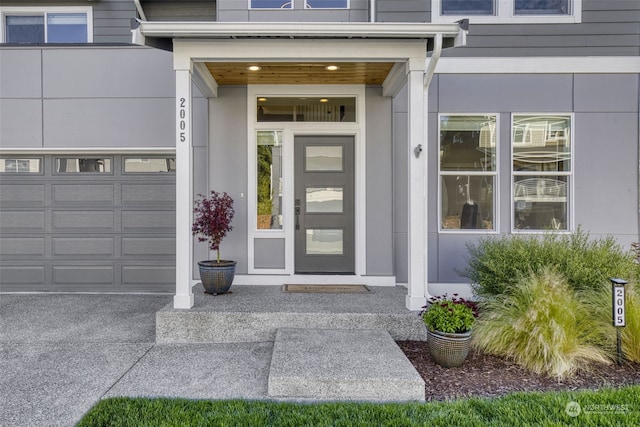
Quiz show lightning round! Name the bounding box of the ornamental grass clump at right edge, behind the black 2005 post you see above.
[579,282,640,363]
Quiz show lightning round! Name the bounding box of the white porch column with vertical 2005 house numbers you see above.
[173,52,193,308]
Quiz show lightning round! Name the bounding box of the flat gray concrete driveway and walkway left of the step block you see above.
[0,294,424,427]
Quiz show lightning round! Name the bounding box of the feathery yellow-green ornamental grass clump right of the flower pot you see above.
[473,267,610,378]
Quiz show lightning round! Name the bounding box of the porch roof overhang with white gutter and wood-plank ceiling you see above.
[137,21,468,97]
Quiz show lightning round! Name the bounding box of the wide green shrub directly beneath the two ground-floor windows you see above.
[458,229,640,298]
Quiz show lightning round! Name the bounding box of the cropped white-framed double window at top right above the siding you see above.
[431,0,582,24]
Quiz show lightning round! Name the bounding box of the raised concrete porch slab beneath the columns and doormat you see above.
[156,285,427,343]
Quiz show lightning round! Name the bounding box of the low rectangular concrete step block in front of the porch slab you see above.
[268,328,425,401]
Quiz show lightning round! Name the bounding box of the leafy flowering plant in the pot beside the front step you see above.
[420,294,477,334]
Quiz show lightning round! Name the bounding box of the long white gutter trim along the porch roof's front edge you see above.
[140,21,465,40]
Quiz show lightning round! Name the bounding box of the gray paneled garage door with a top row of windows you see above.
[0,154,175,292]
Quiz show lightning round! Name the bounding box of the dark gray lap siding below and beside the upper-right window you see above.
[443,0,640,57]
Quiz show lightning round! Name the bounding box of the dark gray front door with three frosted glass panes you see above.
[294,136,355,274]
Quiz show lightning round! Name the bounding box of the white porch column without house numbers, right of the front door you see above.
[406,59,427,310]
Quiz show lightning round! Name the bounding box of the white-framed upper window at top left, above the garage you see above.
[0,6,93,44]
